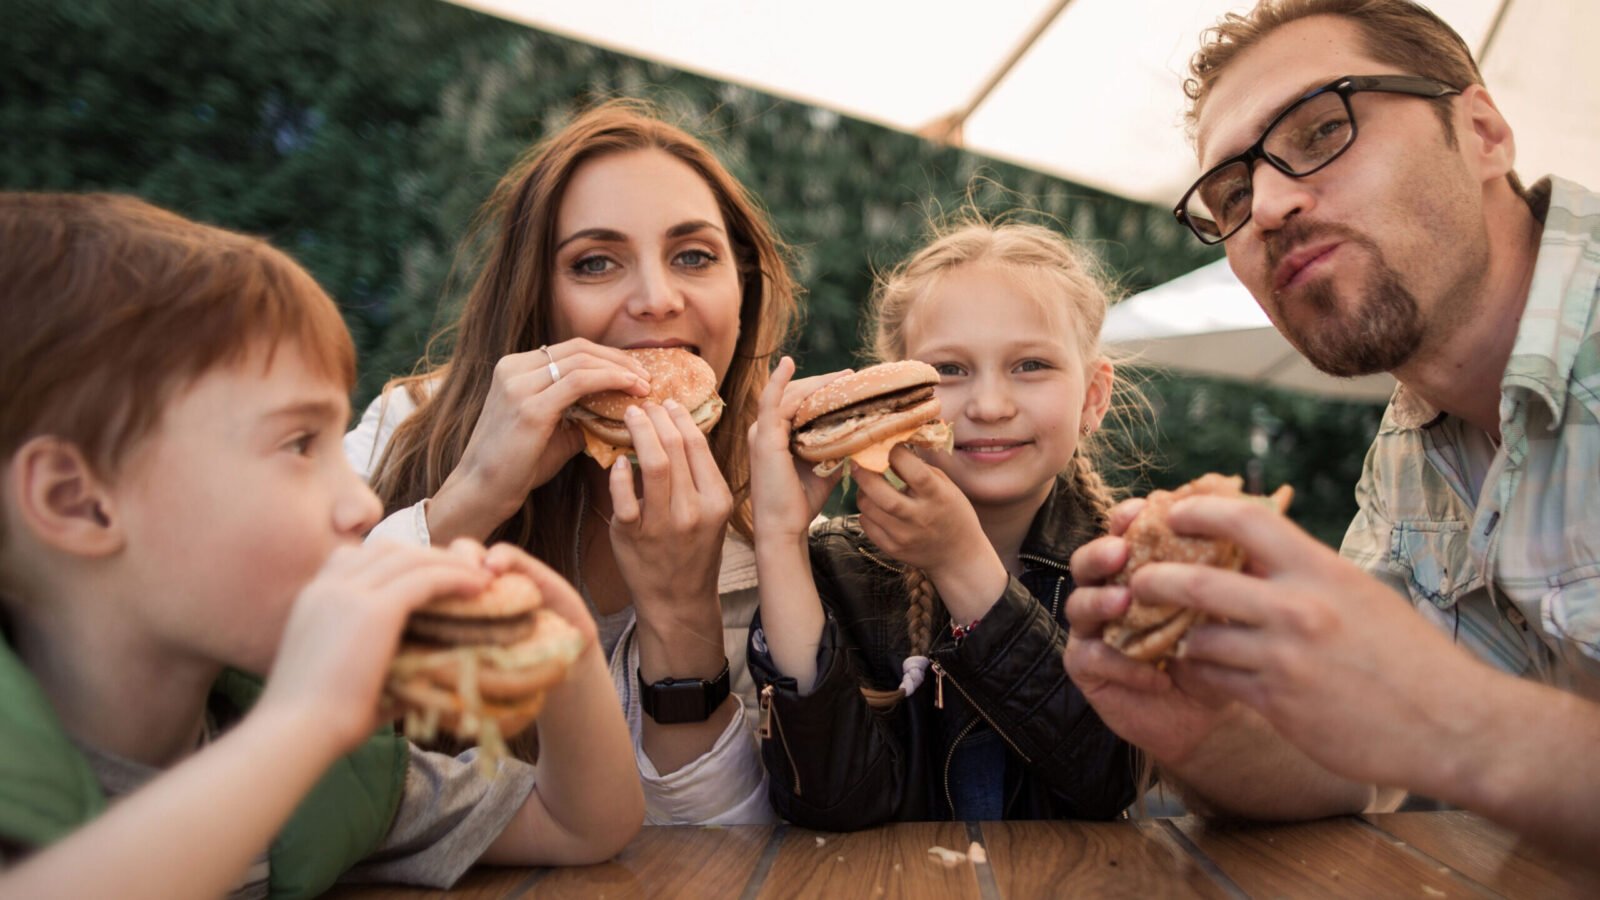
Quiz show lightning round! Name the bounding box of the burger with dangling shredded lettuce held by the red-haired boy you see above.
[384,573,584,765]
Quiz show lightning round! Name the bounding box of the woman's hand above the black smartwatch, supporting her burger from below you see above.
[610,400,733,666]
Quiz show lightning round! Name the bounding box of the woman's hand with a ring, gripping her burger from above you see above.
[429,338,650,543]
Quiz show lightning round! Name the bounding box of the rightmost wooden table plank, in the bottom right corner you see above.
[1363,810,1600,897]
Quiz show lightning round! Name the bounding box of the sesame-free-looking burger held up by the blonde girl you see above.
[790,360,955,476]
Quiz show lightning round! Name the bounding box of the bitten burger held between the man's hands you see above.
[1101,474,1294,663]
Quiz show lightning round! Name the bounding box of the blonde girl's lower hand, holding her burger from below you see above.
[854,444,1010,620]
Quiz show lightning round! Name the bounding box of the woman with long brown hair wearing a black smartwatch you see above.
[346,101,795,823]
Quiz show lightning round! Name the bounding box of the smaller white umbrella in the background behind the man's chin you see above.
[1101,259,1395,402]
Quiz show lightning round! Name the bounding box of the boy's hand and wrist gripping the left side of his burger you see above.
[258,541,486,757]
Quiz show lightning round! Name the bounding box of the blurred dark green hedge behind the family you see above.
[0,0,1376,541]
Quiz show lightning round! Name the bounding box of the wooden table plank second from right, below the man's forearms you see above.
[1168,817,1482,898]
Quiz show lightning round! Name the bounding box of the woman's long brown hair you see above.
[373,101,798,578]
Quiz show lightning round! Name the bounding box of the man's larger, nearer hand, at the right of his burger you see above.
[1130,496,1493,788]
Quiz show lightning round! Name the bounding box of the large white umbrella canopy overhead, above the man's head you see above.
[458,0,1600,205]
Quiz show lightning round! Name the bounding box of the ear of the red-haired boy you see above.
[6,436,123,556]
